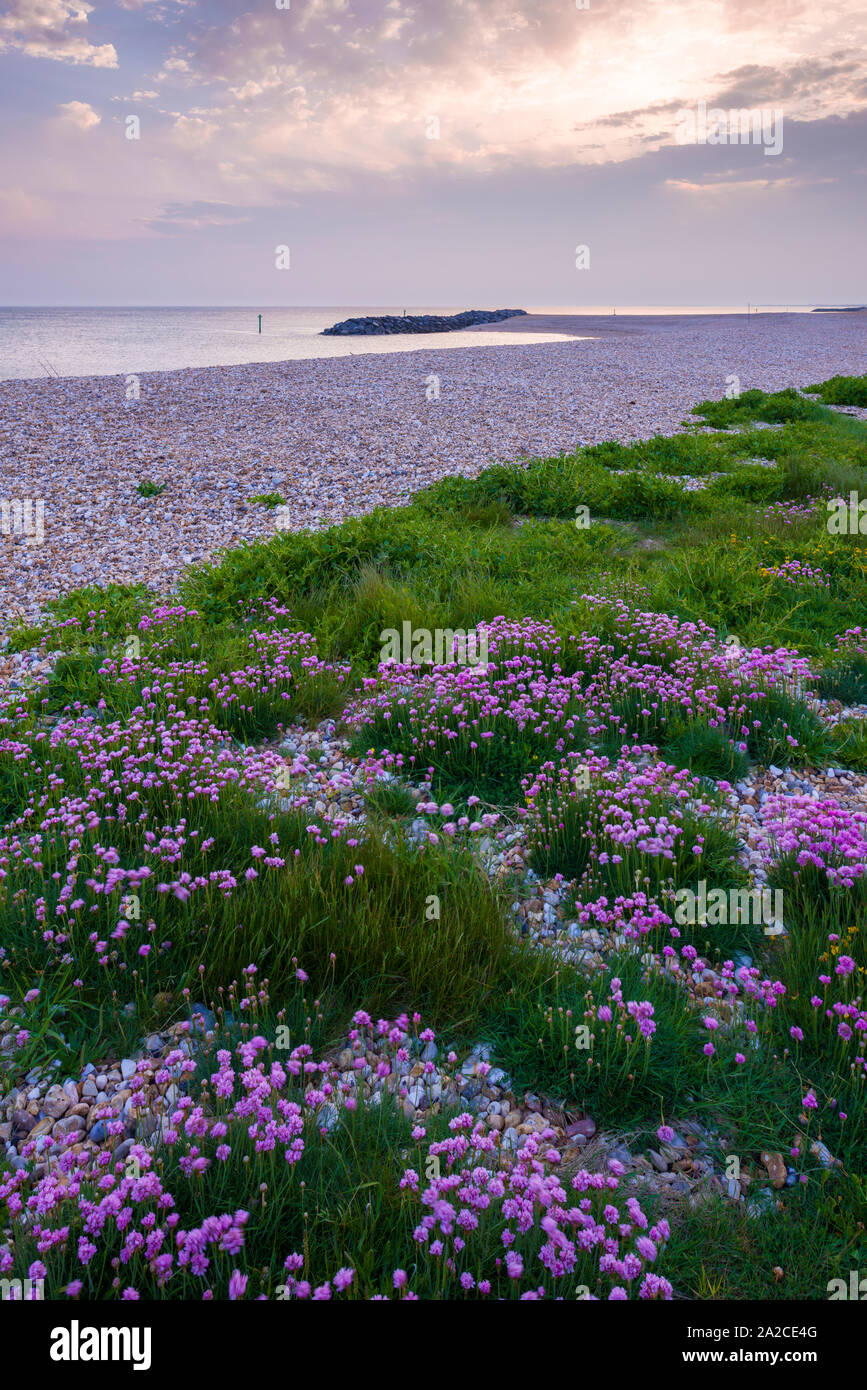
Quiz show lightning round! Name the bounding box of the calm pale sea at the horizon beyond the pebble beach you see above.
[0,304,828,381]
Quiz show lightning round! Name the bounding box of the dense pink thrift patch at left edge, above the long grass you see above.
[0,683,360,984]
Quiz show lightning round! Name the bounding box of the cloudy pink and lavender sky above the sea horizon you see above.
[0,0,867,307]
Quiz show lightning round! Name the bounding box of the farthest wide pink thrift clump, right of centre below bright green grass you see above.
[347,595,810,767]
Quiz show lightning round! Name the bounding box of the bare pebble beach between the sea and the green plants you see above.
[0,314,867,639]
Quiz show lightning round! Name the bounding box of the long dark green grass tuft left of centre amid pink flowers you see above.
[0,792,511,1048]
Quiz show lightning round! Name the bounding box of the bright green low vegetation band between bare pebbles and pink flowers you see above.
[13,392,867,681]
